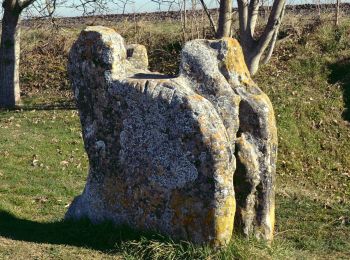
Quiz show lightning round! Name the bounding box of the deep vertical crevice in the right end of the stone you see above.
[233,100,260,235]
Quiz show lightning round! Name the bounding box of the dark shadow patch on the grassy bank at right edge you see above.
[328,58,350,121]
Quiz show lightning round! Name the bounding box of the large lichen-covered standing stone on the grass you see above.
[66,27,277,246]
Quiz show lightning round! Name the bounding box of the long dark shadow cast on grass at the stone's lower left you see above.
[0,211,167,253]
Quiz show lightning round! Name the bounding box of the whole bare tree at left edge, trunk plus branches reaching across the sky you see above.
[0,0,132,108]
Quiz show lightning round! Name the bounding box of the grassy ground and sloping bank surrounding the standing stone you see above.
[0,15,350,259]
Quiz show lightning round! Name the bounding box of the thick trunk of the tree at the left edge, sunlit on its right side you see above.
[0,8,20,108]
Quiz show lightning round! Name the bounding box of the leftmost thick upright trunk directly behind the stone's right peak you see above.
[216,0,232,38]
